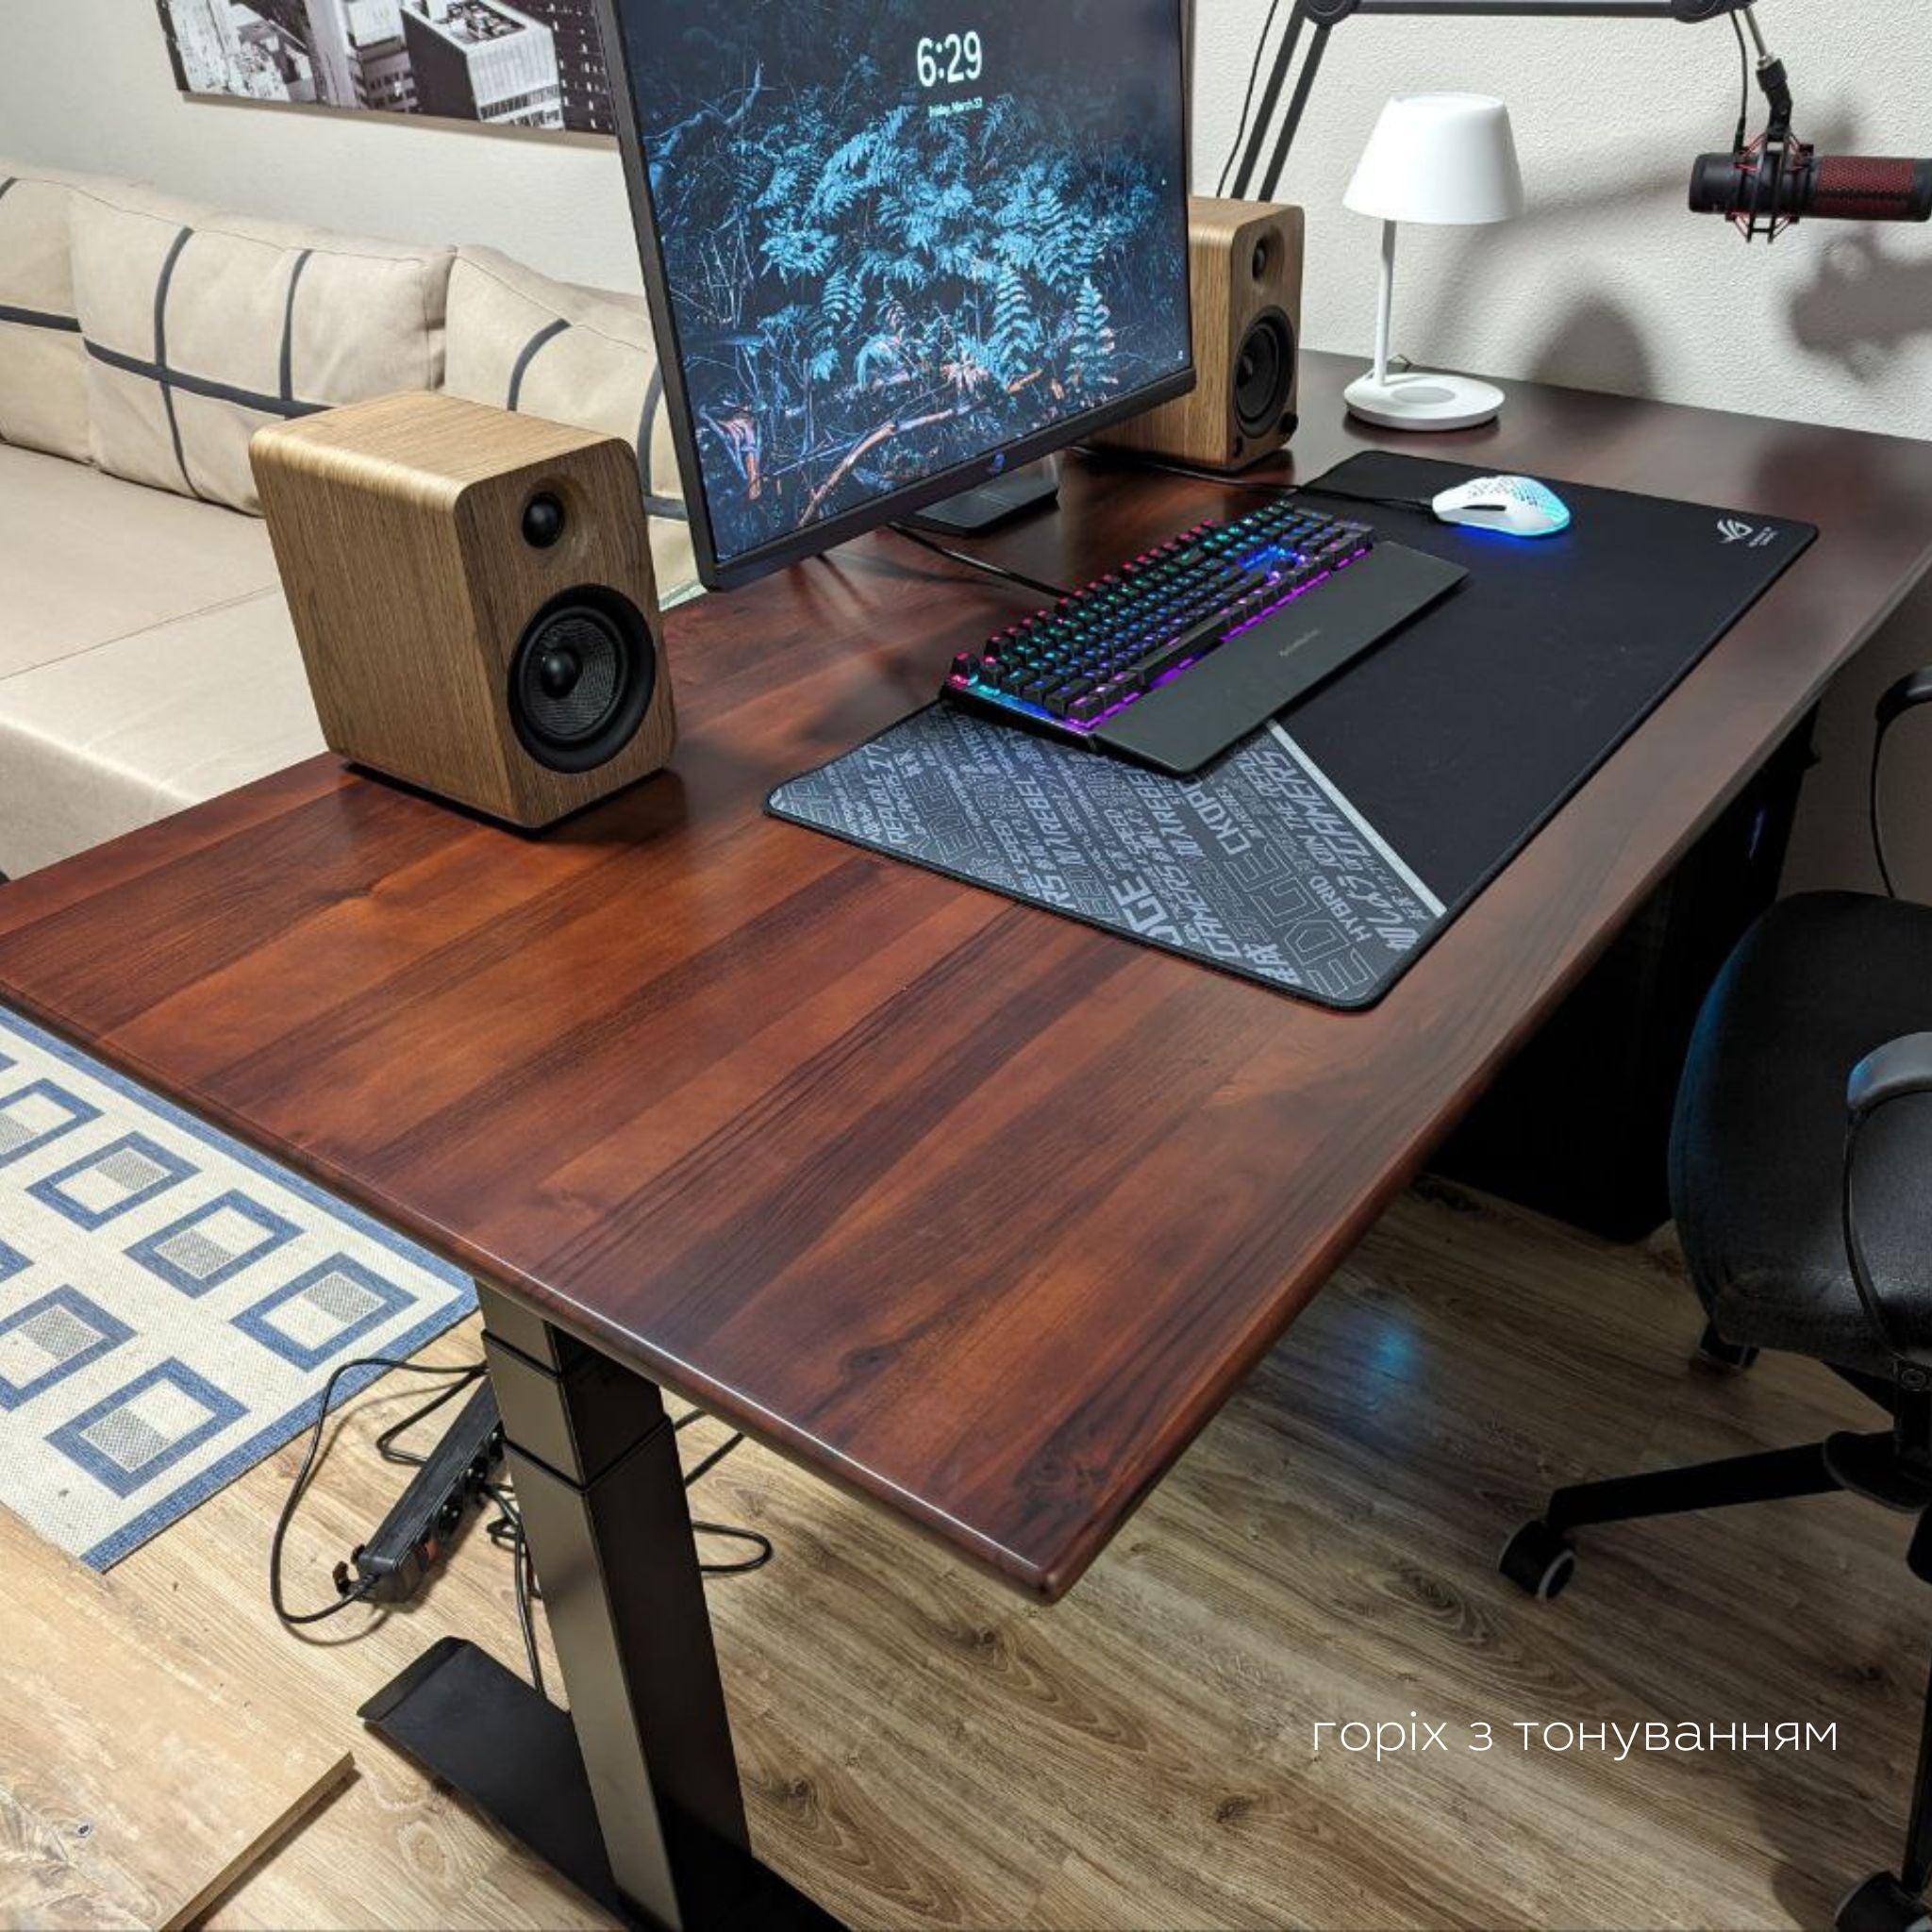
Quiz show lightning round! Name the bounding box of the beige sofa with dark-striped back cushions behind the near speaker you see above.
[0,160,695,877]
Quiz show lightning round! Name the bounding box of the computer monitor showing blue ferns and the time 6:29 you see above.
[603,0,1194,590]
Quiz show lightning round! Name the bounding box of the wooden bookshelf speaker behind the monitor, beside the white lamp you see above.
[1093,195,1304,470]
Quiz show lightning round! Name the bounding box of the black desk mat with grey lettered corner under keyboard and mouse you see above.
[769,454,1816,1008]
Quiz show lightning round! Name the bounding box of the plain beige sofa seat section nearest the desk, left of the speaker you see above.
[0,572,323,877]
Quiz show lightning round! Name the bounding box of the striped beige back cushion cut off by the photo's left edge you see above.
[0,160,87,464]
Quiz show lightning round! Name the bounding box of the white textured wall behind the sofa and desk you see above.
[0,0,1932,892]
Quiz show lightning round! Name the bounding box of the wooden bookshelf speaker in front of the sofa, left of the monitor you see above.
[249,394,676,829]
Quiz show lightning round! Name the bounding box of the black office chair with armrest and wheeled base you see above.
[1499,671,1932,1932]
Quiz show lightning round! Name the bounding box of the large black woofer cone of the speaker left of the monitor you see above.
[510,583,657,771]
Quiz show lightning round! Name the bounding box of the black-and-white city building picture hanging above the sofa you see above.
[157,0,612,133]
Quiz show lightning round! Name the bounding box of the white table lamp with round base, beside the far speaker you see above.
[1344,94,1523,429]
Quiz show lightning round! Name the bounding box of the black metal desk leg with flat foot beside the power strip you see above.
[363,1285,835,1932]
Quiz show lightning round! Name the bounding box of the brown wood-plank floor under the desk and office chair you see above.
[116,1191,1932,1932]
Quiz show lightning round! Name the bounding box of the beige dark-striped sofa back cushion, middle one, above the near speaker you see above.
[72,188,452,510]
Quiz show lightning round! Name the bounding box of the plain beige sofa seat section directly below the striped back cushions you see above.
[0,446,276,679]
